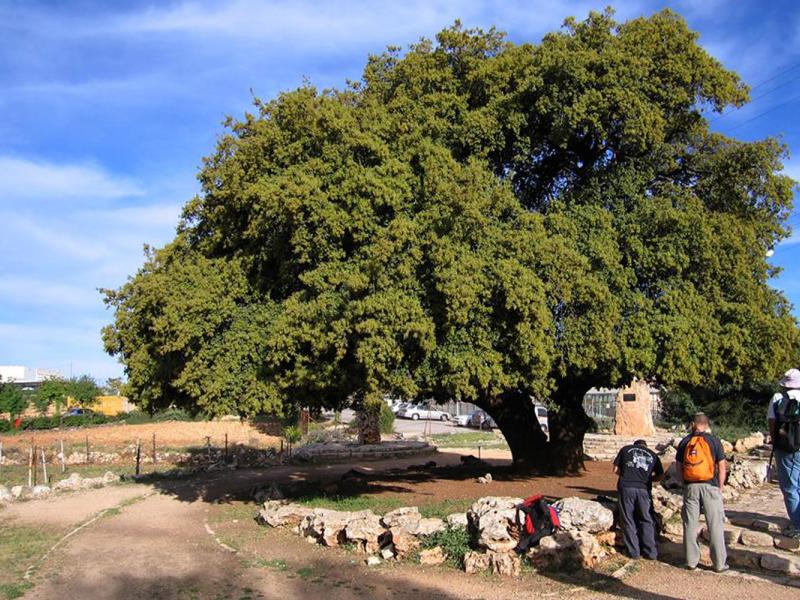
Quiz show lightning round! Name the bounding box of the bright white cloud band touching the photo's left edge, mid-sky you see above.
[0,156,144,204]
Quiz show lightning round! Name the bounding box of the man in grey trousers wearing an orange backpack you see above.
[675,413,728,573]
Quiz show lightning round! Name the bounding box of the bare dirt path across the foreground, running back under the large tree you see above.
[6,453,800,600]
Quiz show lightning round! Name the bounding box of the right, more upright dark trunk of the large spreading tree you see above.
[548,383,591,473]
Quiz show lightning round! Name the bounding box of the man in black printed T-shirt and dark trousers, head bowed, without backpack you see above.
[614,440,664,560]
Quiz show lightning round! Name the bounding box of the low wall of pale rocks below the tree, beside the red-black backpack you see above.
[256,490,614,576]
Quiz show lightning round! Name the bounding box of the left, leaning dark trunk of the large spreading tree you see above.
[479,391,550,471]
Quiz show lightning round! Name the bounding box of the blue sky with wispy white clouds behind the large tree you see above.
[0,0,800,380]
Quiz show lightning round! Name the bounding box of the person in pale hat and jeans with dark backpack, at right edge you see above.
[767,369,800,537]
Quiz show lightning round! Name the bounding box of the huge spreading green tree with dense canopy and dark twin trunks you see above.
[104,11,800,465]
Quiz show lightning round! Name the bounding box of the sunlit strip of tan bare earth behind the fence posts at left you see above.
[0,421,280,449]
